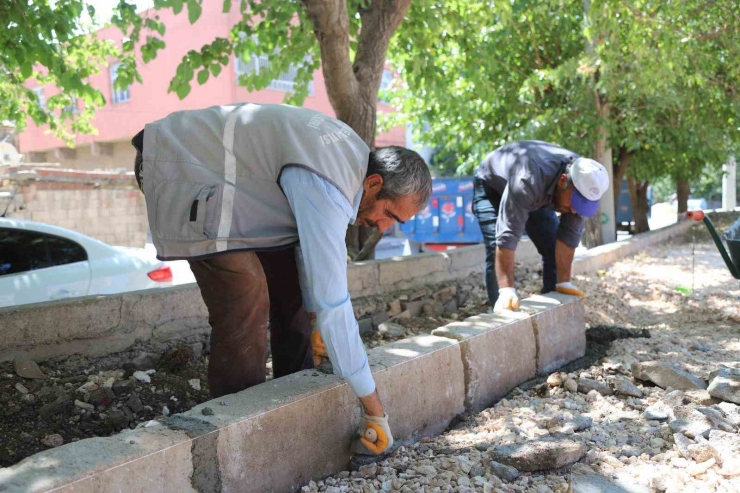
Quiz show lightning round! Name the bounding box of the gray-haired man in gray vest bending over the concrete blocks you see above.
[133,104,432,454]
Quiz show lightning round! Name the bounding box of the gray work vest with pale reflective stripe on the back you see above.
[142,103,370,260]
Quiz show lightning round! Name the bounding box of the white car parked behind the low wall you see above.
[0,217,172,307]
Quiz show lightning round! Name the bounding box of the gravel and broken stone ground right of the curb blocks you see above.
[302,224,740,493]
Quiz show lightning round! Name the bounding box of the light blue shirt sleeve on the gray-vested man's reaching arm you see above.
[280,166,375,397]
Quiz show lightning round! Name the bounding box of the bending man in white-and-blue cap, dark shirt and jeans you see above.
[473,140,609,311]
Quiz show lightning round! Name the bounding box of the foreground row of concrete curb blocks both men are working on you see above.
[0,295,585,493]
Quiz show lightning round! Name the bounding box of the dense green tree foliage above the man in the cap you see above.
[389,0,740,186]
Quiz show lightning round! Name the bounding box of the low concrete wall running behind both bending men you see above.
[0,221,693,361]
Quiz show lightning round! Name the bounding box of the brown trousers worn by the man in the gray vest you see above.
[189,248,313,397]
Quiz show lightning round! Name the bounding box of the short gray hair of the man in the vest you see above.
[367,146,432,208]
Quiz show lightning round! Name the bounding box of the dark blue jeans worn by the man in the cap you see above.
[473,178,560,308]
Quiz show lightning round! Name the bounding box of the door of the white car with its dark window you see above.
[0,228,90,306]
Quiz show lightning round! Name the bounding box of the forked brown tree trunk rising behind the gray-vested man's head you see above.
[302,0,411,260]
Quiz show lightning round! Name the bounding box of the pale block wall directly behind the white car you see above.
[0,166,148,248]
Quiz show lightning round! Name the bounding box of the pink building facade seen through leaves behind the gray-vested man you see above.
[18,0,406,171]
